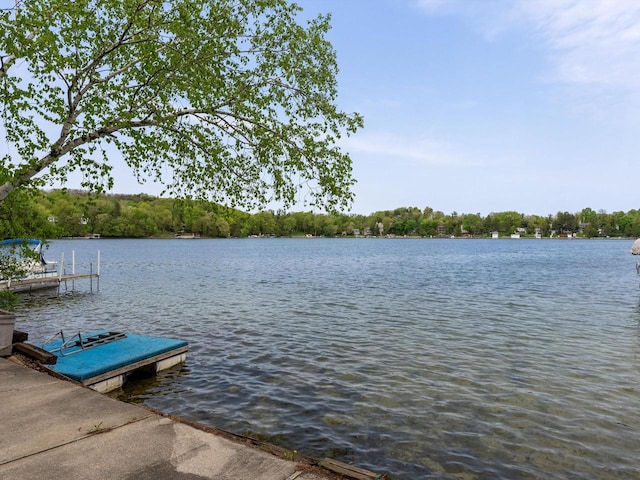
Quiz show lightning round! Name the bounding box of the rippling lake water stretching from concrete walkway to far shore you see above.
[16,239,640,479]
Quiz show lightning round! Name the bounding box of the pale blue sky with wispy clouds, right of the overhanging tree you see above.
[290,0,640,215]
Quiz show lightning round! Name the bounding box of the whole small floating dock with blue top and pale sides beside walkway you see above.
[42,330,189,393]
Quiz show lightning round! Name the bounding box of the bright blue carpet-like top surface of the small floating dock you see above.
[45,330,188,382]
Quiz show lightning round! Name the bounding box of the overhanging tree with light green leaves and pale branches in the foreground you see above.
[0,0,362,209]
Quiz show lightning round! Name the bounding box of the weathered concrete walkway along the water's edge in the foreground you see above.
[0,358,338,480]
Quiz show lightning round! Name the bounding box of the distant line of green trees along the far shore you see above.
[0,190,640,238]
